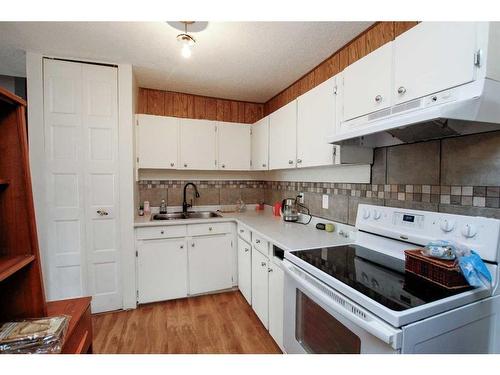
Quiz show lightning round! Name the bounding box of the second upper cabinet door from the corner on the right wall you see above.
[269,100,297,169]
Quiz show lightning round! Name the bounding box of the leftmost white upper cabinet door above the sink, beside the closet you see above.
[136,115,179,169]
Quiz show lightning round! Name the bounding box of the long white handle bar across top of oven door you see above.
[284,263,401,349]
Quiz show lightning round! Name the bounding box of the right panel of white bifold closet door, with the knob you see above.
[82,64,122,312]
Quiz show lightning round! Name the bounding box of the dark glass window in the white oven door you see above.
[295,289,361,354]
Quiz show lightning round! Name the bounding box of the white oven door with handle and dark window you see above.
[283,260,402,354]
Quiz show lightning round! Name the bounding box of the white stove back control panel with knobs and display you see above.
[356,204,500,262]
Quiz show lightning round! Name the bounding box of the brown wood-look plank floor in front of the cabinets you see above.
[92,291,281,354]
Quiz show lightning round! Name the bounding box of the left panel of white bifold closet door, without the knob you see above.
[44,60,87,300]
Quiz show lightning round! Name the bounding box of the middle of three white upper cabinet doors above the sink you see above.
[179,119,217,170]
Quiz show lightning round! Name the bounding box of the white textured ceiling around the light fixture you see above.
[0,22,372,102]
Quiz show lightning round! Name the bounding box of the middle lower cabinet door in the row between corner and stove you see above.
[252,249,269,328]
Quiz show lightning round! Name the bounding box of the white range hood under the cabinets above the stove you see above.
[328,78,500,147]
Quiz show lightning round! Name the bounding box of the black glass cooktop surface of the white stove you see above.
[291,245,470,311]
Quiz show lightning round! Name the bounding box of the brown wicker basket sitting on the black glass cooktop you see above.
[405,249,469,289]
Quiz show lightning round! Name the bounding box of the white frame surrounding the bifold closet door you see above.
[26,52,138,309]
